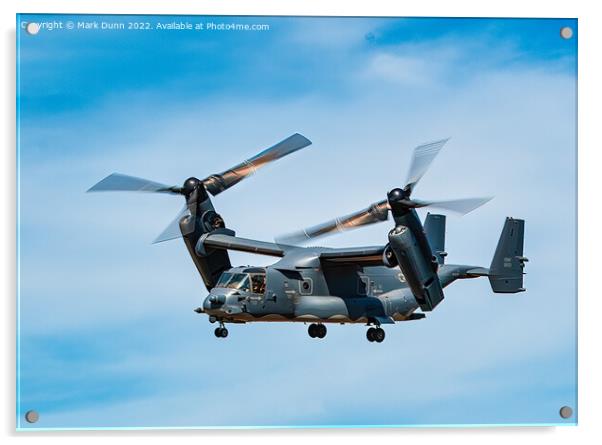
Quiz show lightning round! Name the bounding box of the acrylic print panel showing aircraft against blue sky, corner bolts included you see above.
[17,14,577,429]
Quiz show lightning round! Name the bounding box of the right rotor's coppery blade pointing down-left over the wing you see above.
[276,200,389,244]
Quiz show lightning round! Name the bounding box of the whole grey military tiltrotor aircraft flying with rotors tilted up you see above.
[89,134,527,343]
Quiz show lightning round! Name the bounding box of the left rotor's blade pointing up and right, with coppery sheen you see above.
[203,133,311,196]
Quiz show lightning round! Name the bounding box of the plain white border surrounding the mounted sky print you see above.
[0,0,602,445]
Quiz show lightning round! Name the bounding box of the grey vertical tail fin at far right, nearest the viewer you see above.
[488,218,528,294]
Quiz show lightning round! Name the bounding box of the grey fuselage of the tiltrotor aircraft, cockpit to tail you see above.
[202,248,471,324]
